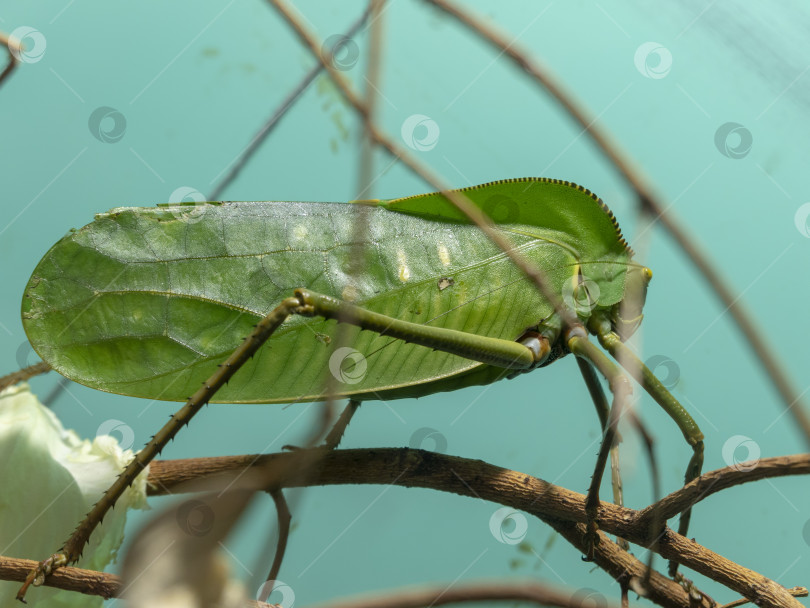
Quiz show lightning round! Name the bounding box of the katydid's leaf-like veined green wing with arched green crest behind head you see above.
[23,180,630,402]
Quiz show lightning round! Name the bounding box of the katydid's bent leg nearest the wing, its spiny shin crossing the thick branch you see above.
[565,327,633,561]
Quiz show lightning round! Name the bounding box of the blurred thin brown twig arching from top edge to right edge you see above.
[426,0,810,444]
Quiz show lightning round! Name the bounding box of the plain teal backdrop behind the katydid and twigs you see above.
[0,0,810,608]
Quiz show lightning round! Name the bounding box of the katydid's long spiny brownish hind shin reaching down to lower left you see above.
[17,298,306,602]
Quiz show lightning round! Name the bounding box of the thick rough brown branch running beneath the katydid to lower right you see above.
[145,448,804,607]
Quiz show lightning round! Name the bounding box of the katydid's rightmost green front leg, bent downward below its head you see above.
[589,315,703,578]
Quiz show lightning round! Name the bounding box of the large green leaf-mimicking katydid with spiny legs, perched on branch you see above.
[17,178,703,592]
